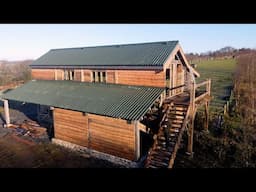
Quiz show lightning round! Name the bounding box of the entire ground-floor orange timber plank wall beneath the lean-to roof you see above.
[54,108,136,160]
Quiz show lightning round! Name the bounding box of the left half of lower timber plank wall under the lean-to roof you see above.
[53,108,88,147]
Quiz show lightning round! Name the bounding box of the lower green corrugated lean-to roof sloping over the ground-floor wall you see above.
[1,80,164,120]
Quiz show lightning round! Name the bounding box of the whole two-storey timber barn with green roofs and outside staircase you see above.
[1,41,210,167]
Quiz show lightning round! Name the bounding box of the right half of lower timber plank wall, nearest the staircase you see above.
[88,114,135,160]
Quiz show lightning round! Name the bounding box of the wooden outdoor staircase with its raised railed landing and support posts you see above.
[145,80,211,168]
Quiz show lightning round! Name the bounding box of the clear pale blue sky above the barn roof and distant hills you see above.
[0,24,256,60]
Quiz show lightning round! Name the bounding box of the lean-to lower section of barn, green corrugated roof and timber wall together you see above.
[2,80,165,161]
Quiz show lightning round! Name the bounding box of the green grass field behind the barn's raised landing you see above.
[196,59,236,113]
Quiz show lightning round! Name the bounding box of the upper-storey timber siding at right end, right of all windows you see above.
[117,70,165,87]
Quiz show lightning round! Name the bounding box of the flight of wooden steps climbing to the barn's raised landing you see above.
[145,102,189,168]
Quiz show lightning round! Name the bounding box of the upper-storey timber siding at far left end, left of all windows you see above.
[31,69,55,80]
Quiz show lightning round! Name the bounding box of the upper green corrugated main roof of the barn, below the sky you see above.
[30,41,178,68]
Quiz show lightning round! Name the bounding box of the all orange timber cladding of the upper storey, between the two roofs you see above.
[32,69,165,87]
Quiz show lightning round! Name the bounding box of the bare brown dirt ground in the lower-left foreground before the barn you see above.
[0,133,124,168]
